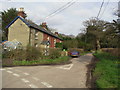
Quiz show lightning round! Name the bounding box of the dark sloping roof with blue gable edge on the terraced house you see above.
[6,16,62,40]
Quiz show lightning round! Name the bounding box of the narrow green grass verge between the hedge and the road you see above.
[13,56,70,66]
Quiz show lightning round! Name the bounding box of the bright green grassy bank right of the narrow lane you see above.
[93,52,120,88]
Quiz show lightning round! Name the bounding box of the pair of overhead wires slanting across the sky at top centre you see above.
[45,0,76,19]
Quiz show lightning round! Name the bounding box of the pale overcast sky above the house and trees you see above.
[0,0,118,35]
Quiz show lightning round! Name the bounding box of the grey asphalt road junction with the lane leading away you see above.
[0,54,92,88]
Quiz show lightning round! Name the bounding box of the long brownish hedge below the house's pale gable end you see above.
[2,46,42,61]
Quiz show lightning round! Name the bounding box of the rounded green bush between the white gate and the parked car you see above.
[49,49,61,59]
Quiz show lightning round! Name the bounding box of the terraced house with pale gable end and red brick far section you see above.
[6,8,62,48]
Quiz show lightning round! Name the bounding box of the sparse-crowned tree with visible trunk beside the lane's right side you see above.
[84,18,106,50]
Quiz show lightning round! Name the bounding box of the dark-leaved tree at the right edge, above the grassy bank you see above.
[104,21,120,48]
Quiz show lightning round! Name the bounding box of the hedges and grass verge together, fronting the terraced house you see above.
[2,46,70,67]
